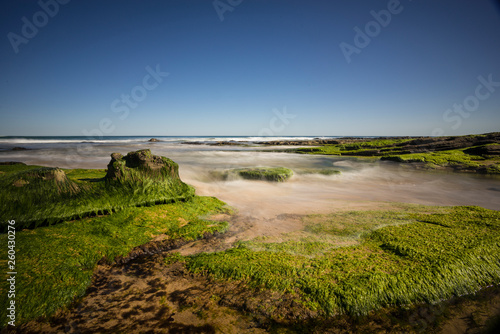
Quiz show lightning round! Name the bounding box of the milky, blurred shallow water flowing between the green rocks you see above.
[0,142,500,217]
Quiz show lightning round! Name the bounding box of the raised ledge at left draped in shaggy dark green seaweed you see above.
[0,151,194,232]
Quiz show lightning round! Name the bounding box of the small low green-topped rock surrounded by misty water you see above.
[212,167,293,182]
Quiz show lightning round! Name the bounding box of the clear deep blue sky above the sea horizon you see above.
[0,0,500,136]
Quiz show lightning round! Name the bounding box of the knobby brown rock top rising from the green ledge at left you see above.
[106,149,179,180]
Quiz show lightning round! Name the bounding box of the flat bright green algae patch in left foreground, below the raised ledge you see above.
[0,196,229,326]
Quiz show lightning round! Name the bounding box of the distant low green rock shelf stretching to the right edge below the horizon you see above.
[183,132,500,174]
